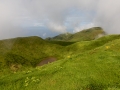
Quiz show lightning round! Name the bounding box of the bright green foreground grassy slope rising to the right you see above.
[0,35,120,90]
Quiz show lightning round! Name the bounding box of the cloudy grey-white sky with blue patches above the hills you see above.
[0,0,120,39]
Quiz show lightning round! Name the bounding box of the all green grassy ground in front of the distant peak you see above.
[0,35,120,90]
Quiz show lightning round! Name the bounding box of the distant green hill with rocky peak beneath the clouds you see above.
[46,27,105,42]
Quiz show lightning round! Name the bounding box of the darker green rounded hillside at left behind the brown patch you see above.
[0,37,68,67]
